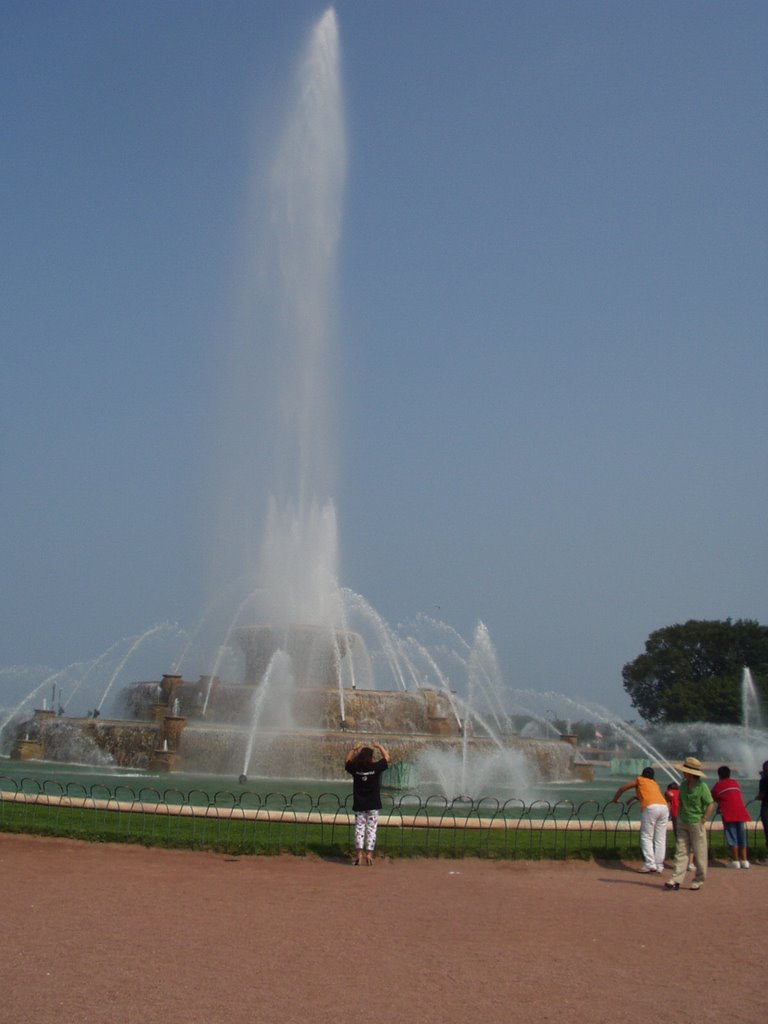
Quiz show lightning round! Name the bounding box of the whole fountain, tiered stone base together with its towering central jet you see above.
[1,9,579,793]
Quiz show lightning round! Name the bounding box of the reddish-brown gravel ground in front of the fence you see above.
[0,834,768,1024]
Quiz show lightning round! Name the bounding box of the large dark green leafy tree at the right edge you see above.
[622,618,768,724]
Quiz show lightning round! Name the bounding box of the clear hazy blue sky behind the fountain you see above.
[0,0,768,715]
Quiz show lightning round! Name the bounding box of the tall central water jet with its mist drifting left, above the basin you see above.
[218,8,346,628]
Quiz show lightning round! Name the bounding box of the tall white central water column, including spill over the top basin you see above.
[230,8,346,761]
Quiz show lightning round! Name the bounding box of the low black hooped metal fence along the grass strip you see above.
[0,775,765,859]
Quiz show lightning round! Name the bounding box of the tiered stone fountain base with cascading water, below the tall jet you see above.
[6,624,590,796]
